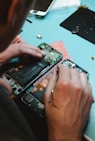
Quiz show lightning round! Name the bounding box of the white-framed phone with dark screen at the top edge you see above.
[29,0,55,16]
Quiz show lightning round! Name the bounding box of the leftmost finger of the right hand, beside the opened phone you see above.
[45,69,57,102]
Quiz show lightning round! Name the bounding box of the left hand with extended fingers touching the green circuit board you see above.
[0,36,45,66]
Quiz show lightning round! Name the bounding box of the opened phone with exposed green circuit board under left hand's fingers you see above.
[1,43,63,95]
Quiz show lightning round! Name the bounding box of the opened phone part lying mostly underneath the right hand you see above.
[21,59,89,117]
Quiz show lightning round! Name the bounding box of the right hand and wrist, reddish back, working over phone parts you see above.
[45,64,93,141]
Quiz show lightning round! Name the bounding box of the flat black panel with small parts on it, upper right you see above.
[60,6,95,44]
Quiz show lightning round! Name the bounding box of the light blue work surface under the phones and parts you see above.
[20,0,95,141]
